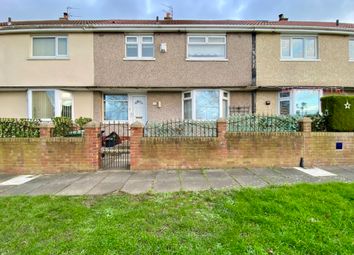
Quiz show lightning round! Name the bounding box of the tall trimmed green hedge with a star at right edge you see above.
[321,95,354,132]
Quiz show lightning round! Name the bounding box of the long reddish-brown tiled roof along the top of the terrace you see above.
[0,19,354,32]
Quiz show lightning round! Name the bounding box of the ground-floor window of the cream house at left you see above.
[27,89,73,121]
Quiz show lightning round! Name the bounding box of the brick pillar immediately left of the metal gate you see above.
[83,121,102,170]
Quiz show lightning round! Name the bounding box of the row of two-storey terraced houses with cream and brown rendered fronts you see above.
[0,14,354,123]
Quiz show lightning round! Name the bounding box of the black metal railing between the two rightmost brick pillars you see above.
[227,115,299,132]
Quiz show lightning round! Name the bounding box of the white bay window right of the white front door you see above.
[183,89,229,120]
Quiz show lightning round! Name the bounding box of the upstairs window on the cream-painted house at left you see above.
[32,36,68,58]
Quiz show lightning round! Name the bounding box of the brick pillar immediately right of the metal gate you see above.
[130,121,144,170]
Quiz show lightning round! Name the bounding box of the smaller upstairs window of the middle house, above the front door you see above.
[125,35,154,59]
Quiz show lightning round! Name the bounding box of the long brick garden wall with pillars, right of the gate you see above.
[131,118,354,170]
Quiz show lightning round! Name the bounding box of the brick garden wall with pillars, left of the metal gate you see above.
[0,122,101,174]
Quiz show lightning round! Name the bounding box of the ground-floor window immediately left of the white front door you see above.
[104,94,128,121]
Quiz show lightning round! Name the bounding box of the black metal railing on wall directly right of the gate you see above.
[144,120,217,137]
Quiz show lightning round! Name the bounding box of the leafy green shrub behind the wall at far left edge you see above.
[0,118,40,138]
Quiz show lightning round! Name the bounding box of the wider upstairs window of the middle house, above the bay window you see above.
[187,35,226,60]
